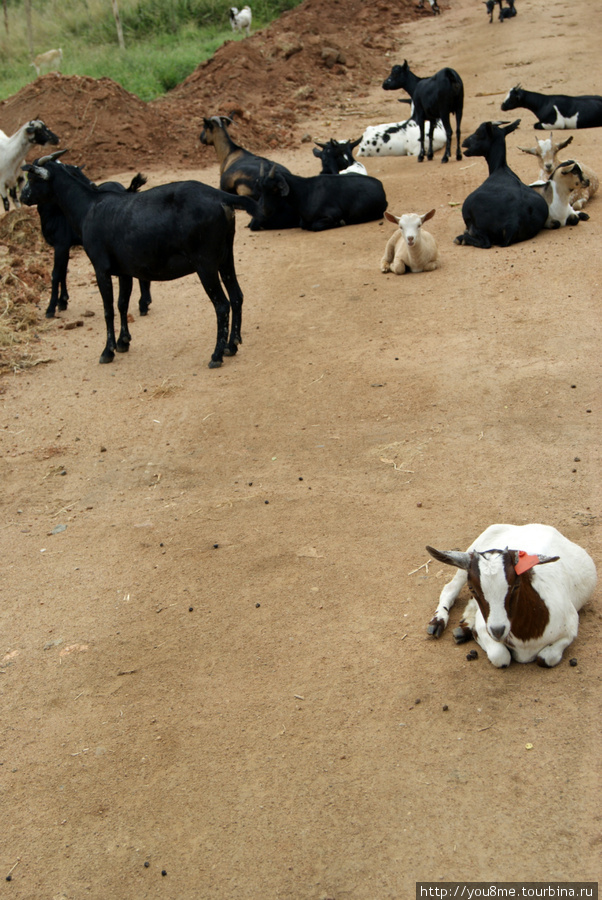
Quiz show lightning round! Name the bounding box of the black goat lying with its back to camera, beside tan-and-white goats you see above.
[454,119,548,249]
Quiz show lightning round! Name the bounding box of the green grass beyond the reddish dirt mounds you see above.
[0,0,300,102]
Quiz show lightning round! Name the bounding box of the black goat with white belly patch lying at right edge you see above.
[502,84,602,131]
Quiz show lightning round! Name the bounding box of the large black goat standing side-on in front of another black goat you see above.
[23,150,257,368]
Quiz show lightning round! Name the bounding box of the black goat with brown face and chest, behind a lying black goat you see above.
[199,116,299,231]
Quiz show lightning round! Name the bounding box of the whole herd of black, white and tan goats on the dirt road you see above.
[0,40,602,667]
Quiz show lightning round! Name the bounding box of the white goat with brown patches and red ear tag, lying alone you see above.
[426,524,597,668]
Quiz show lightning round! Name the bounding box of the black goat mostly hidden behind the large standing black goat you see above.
[23,166,152,319]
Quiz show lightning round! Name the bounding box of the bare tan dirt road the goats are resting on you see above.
[0,0,602,900]
